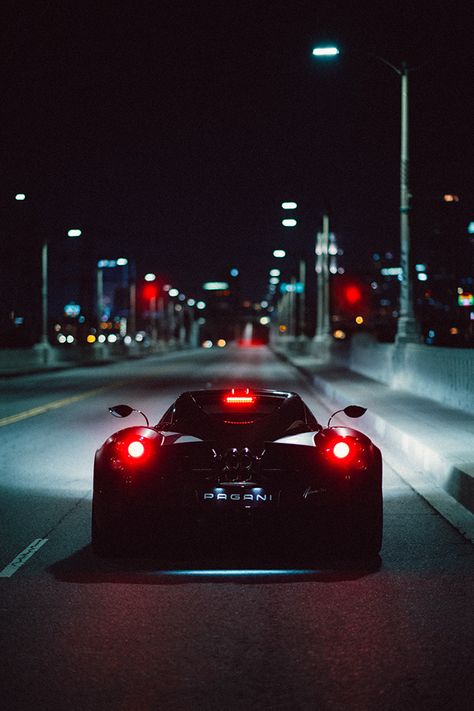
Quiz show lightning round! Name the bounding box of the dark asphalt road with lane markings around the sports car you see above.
[0,348,474,711]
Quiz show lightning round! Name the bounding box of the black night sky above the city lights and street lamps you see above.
[0,0,474,310]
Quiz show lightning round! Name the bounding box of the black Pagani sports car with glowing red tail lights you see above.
[92,388,382,555]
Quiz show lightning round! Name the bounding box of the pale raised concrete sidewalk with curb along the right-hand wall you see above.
[274,350,474,542]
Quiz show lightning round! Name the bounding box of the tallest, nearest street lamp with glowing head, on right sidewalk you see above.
[313,47,419,343]
